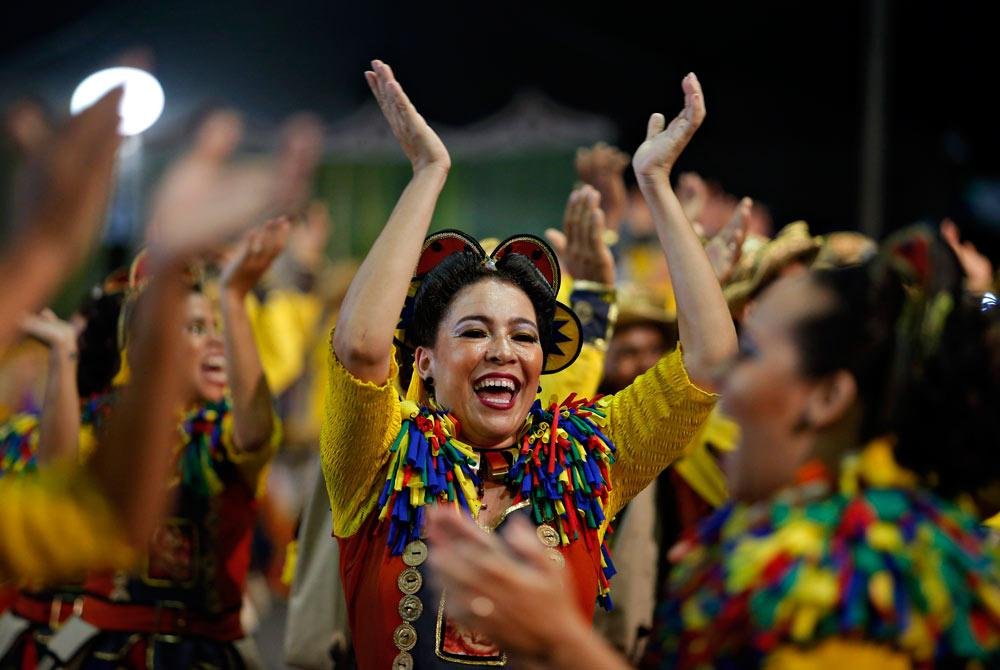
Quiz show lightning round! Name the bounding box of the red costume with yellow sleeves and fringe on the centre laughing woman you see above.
[321,338,715,668]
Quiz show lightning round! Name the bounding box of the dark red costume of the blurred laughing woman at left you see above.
[39,397,280,668]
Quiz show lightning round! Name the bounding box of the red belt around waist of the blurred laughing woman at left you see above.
[80,598,243,642]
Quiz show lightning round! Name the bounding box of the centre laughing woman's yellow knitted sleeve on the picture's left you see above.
[319,333,402,537]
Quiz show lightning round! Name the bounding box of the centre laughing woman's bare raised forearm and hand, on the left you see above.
[333,60,451,384]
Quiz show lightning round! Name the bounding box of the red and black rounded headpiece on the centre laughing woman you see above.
[396,230,583,374]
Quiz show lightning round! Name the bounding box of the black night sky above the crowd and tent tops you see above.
[0,0,1000,257]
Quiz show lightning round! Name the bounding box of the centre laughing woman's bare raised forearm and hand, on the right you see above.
[632,73,736,388]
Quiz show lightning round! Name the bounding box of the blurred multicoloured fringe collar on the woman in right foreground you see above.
[644,456,1000,667]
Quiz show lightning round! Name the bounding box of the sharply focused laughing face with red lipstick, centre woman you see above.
[416,279,543,448]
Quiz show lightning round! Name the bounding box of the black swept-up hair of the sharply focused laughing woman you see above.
[397,252,555,388]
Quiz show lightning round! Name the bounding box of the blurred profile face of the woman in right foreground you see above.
[721,276,828,500]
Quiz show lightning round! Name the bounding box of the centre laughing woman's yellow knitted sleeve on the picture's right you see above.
[606,345,718,519]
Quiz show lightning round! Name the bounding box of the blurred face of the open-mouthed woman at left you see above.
[183,293,227,402]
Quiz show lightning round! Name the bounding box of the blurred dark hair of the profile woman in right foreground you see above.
[795,240,1000,495]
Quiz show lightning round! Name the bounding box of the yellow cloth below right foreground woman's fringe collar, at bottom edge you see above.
[763,638,912,670]
